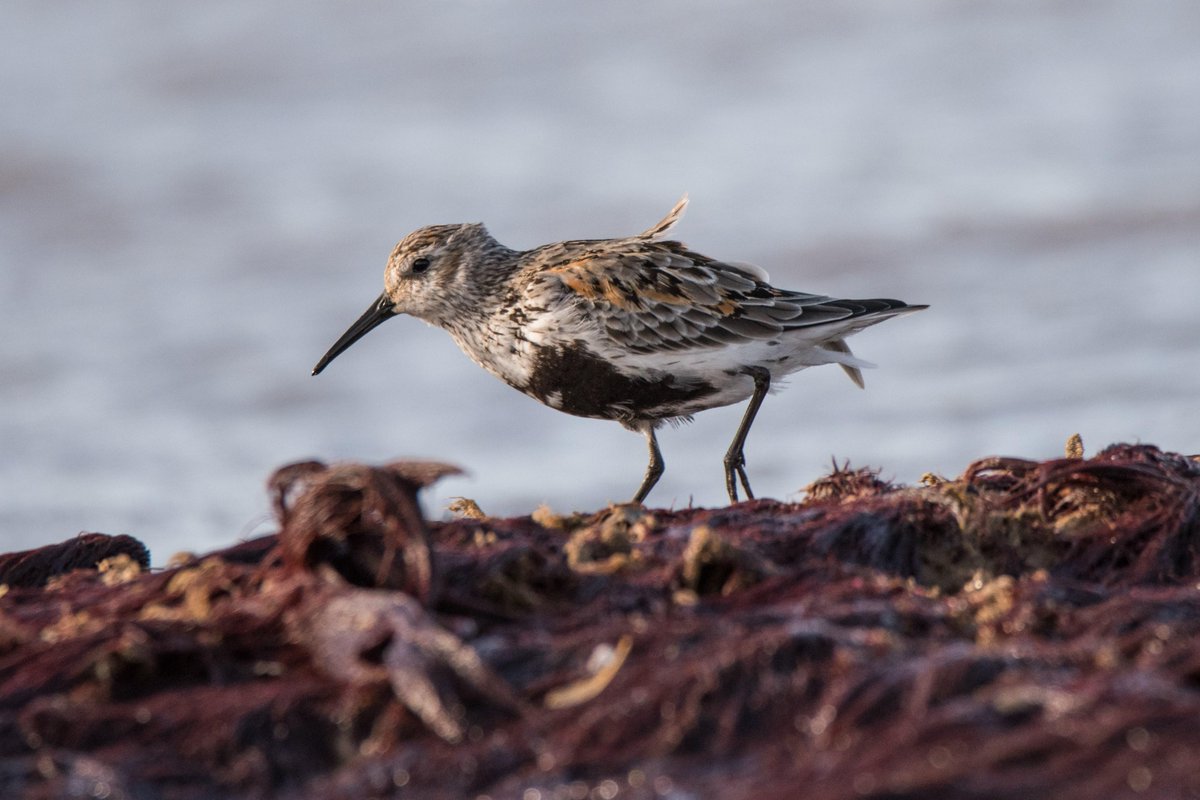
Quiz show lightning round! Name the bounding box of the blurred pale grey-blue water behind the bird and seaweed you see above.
[0,0,1200,564]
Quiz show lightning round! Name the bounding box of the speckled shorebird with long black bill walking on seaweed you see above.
[312,194,928,504]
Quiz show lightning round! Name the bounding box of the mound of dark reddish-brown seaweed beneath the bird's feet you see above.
[0,445,1200,799]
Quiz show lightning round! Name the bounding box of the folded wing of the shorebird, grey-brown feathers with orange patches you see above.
[534,236,883,353]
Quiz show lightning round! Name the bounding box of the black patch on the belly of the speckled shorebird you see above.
[524,345,716,420]
